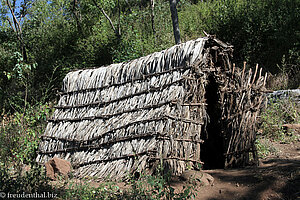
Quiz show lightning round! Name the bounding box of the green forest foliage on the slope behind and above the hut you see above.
[0,0,300,110]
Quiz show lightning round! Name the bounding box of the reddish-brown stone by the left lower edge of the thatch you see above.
[45,157,71,180]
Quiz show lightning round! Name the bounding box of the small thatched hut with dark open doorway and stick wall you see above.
[36,36,266,179]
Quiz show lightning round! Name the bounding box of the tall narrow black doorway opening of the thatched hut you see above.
[200,75,225,169]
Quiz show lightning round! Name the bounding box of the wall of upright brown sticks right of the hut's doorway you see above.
[220,63,267,167]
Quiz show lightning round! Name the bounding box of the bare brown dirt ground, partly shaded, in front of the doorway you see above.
[180,141,300,200]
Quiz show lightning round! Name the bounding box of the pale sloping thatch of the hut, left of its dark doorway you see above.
[37,37,266,178]
